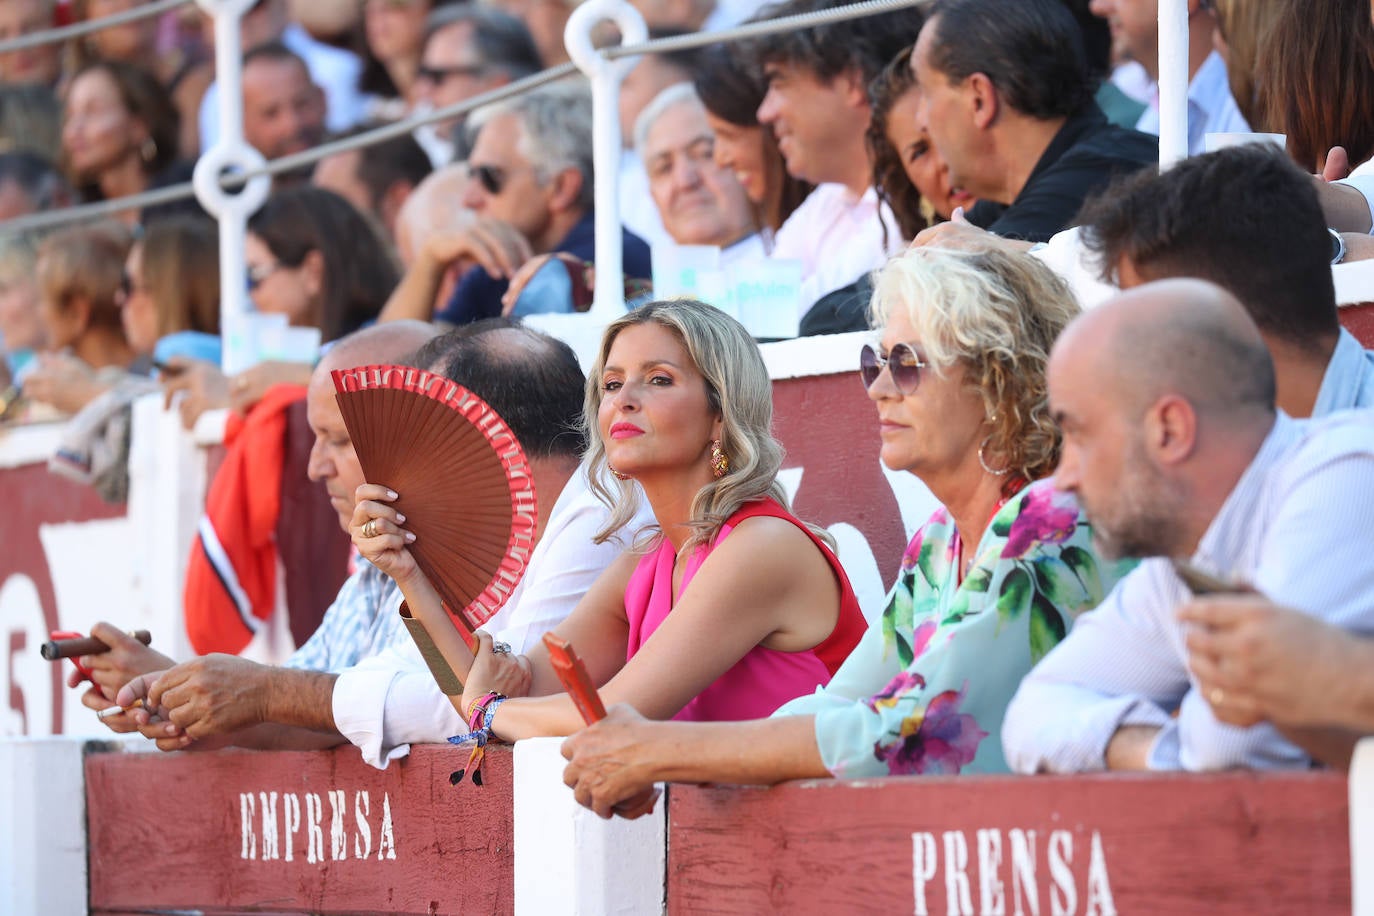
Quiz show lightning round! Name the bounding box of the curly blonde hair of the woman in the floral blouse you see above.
[870,247,1080,481]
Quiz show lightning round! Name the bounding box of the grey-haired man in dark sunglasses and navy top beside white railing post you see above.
[381,82,650,324]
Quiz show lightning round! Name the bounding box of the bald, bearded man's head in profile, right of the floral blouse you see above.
[1048,280,1275,556]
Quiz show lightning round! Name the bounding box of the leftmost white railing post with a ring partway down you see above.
[191,0,272,375]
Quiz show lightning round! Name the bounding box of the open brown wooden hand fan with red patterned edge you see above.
[333,365,537,651]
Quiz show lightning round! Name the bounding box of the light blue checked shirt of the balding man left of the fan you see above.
[286,558,411,672]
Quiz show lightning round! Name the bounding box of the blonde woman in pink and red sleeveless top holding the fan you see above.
[352,299,866,740]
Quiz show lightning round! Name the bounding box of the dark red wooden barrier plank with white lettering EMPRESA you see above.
[87,746,514,913]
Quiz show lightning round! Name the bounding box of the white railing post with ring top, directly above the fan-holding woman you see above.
[563,0,649,321]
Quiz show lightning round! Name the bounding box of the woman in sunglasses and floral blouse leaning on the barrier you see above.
[552,247,1118,817]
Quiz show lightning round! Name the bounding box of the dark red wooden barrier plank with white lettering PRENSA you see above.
[668,773,1351,916]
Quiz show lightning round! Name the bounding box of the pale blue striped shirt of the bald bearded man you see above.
[1002,411,1374,773]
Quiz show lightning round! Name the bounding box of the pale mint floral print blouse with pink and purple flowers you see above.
[775,479,1134,776]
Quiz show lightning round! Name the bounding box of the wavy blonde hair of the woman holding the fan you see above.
[583,299,789,548]
